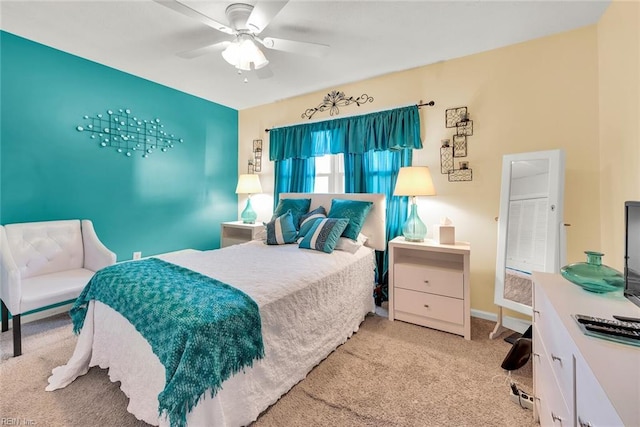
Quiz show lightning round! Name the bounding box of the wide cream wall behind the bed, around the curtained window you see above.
[239,25,601,318]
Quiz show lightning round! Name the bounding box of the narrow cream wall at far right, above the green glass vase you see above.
[598,1,640,271]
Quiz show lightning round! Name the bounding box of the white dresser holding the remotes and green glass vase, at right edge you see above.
[532,272,640,427]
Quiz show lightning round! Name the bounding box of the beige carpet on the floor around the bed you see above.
[0,315,534,427]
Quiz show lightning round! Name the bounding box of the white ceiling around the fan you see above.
[0,0,610,110]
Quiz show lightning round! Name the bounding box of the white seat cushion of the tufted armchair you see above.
[20,268,94,314]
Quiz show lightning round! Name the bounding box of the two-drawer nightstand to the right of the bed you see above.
[389,237,471,340]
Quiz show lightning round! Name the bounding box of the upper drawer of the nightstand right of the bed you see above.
[394,263,464,299]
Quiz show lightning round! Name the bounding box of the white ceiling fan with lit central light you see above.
[154,0,329,77]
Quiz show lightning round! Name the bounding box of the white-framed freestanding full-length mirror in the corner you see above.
[489,150,566,338]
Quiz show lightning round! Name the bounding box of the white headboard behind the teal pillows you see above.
[280,193,387,251]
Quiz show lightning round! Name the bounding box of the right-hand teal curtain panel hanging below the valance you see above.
[344,149,413,290]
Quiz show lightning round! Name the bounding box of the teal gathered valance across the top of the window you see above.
[269,105,422,161]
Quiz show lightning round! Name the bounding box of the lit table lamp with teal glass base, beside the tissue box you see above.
[393,166,436,242]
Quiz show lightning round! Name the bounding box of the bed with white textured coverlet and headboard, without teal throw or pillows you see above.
[47,193,386,426]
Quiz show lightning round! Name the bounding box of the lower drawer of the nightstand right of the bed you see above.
[394,288,464,325]
